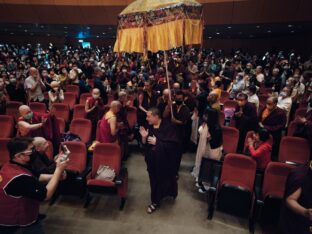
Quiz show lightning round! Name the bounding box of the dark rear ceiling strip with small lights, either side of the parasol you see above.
[0,21,312,39]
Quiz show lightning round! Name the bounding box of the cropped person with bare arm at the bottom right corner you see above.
[279,161,312,234]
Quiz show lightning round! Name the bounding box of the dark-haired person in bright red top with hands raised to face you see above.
[247,129,272,170]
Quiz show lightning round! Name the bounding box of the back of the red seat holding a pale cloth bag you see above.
[91,143,121,179]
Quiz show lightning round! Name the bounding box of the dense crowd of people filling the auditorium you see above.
[0,44,312,232]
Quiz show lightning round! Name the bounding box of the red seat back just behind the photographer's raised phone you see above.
[64,141,87,173]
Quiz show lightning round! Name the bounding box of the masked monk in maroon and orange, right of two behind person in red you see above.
[259,97,287,160]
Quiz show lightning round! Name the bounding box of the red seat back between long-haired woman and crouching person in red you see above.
[222,126,239,154]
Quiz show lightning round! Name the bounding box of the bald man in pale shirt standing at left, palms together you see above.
[24,67,46,102]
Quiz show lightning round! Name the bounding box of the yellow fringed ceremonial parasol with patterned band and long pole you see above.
[114,0,203,112]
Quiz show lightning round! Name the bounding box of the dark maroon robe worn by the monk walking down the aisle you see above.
[144,120,179,205]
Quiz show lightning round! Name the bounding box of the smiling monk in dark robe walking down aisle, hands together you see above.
[140,108,179,214]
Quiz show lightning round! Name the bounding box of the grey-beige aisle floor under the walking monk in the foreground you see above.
[41,150,260,234]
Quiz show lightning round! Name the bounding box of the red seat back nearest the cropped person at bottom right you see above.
[262,162,295,199]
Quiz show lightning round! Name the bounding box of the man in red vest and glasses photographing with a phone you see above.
[0,138,68,234]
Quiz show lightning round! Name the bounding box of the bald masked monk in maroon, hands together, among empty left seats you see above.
[85,88,104,136]
